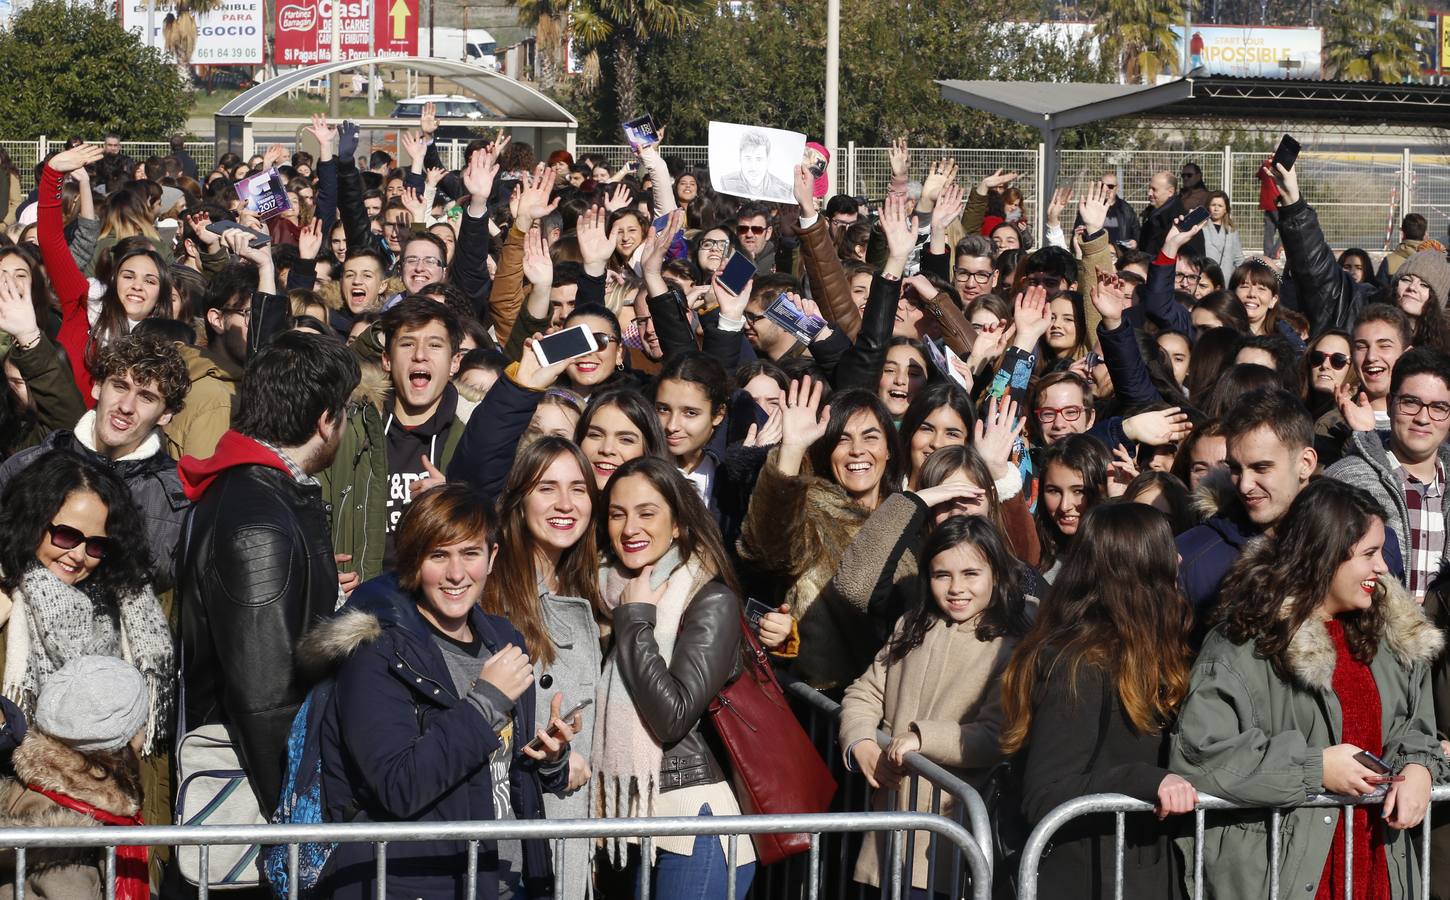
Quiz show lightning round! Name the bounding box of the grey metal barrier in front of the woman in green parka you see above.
[1018,784,1450,900]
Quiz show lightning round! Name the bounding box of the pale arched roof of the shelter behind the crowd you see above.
[216,57,579,128]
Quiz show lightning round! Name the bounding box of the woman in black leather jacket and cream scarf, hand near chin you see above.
[592,458,755,900]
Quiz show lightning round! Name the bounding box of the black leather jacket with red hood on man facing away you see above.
[178,449,338,809]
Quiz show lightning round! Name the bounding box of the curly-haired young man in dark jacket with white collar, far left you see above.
[0,335,191,593]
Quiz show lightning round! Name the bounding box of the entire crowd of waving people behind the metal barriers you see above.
[0,109,1450,900]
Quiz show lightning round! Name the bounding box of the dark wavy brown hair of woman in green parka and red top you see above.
[1215,478,1385,680]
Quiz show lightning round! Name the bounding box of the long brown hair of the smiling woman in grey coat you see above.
[483,436,605,667]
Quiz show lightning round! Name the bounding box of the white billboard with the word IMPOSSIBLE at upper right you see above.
[1173,25,1324,78]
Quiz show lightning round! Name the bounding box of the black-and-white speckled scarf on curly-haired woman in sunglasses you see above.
[3,564,177,755]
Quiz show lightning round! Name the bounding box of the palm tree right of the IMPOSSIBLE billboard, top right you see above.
[1324,0,1431,84]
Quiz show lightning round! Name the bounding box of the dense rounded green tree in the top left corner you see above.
[0,0,190,139]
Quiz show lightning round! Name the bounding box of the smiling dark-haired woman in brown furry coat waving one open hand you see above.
[740,377,903,688]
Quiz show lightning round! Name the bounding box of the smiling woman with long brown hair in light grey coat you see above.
[483,438,602,900]
